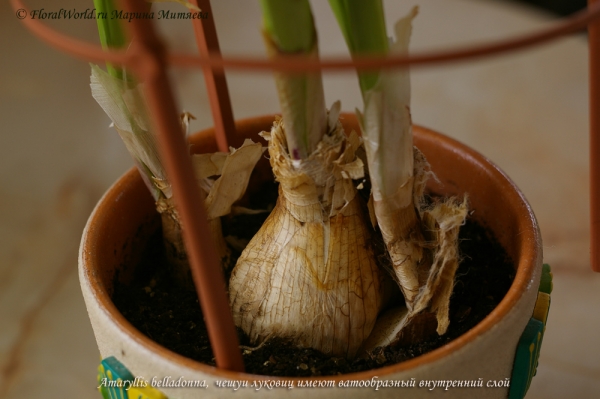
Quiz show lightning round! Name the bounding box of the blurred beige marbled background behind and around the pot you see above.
[0,0,600,399]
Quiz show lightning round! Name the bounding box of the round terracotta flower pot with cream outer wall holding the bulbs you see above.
[79,114,542,399]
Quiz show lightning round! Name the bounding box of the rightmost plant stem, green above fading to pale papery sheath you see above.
[329,0,417,202]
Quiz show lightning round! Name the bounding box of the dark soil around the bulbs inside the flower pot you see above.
[113,186,515,376]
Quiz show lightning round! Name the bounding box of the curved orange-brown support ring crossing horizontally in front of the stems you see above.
[11,0,600,72]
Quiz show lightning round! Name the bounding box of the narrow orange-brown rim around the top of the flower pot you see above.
[80,114,541,382]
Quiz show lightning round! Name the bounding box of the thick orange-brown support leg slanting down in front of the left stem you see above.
[115,0,244,372]
